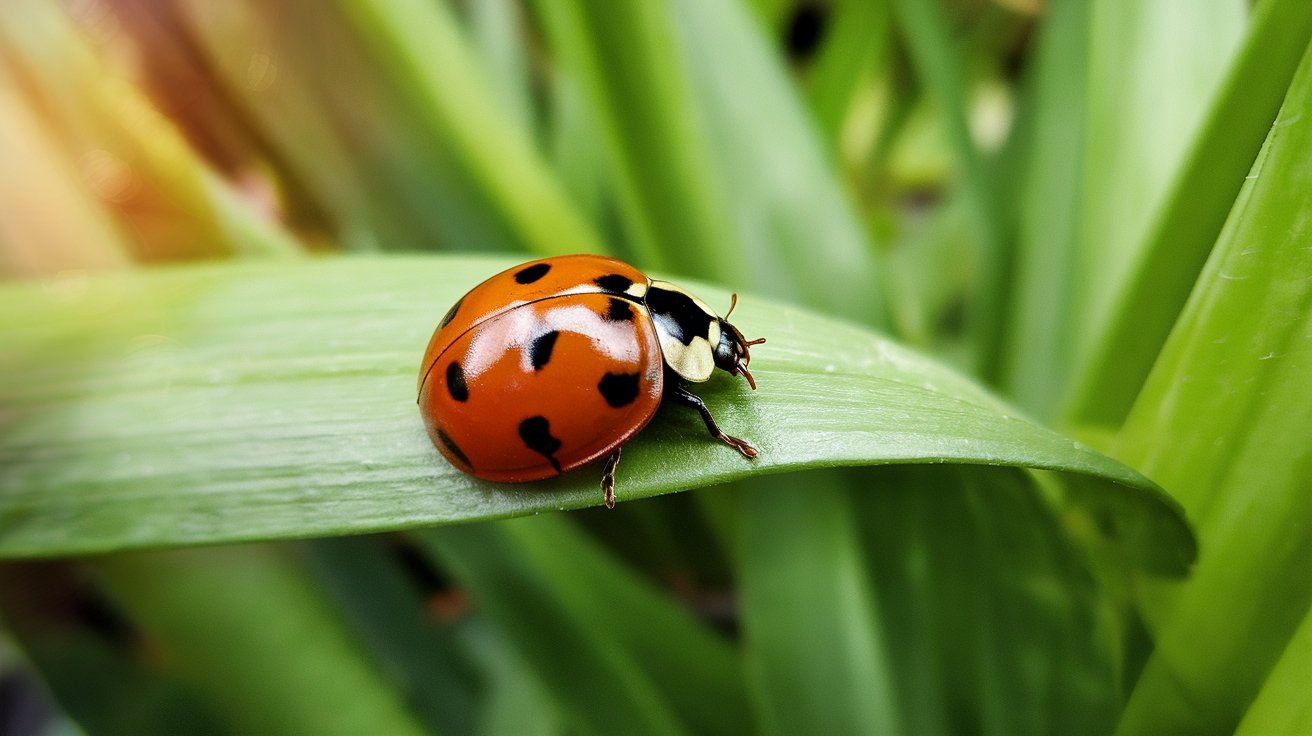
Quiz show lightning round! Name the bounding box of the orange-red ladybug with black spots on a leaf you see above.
[419,256,765,508]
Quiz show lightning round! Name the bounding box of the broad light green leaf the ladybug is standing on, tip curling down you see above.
[0,251,1191,567]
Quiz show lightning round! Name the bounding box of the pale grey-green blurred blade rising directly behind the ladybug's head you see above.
[670,0,886,325]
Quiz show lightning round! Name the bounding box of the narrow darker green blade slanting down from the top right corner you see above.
[1068,0,1312,425]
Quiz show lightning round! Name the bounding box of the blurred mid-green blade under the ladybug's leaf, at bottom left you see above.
[93,547,424,736]
